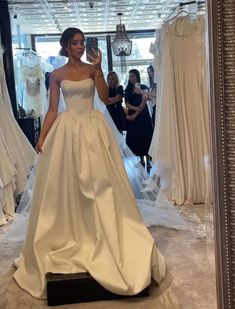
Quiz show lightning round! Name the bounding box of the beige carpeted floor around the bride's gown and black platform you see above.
[0,201,216,309]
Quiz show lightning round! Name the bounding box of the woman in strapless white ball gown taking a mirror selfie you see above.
[14,28,166,298]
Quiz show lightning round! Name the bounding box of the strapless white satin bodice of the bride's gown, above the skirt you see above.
[60,78,95,113]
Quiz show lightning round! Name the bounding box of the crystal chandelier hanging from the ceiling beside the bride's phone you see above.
[111,13,132,57]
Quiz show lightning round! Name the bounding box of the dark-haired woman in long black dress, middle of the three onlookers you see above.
[125,69,153,168]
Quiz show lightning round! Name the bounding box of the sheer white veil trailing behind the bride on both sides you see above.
[0,86,192,242]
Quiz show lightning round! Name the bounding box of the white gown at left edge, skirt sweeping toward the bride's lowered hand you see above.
[0,60,35,196]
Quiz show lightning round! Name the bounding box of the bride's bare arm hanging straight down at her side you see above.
[35,73,60,153]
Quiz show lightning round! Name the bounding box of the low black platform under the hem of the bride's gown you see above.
[46,273,149,306]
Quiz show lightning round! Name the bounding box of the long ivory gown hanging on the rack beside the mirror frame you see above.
[149,17,211,205]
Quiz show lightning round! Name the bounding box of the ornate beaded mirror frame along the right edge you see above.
[207,0,235,309]
